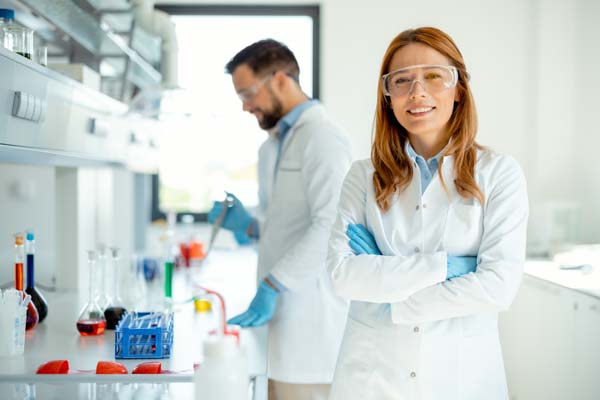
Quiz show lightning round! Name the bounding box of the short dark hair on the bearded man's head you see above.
[225,39,300,81]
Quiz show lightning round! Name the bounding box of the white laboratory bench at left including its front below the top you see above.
[0,248,268,400]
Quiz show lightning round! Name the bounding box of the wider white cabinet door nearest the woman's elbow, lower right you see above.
[501,276,575,400]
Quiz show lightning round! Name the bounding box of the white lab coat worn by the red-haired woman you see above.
[328,151,528,400]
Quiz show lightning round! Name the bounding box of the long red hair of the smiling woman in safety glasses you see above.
[371,27,484,211]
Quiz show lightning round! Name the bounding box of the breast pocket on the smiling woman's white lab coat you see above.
[444,202,483,256]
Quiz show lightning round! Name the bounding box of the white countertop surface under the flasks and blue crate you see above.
[0,248,267,398]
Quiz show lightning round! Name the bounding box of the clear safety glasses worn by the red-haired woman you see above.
[381,65,458,97]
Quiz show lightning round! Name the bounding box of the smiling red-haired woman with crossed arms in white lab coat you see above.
[328,28,528,400]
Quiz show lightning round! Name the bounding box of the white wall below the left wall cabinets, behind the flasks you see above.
[0,164,134,288]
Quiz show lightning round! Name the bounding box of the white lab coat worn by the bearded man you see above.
[258,104,352,383]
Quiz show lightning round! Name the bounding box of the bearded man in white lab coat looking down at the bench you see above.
[209,39,351,400]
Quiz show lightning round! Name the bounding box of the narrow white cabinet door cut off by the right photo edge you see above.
[573,293,600,400]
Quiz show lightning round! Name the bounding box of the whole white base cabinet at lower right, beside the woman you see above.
[500,275,600,400]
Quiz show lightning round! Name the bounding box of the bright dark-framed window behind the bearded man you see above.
[152,6,319,220]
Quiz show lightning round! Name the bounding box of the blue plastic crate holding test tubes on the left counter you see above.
[115,312,173,358]
